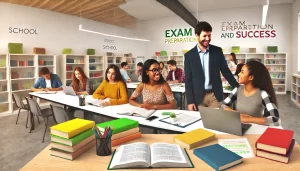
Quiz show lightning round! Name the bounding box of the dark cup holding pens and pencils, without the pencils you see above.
[96,137,111,156]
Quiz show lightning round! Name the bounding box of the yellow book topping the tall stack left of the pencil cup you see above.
[50,118,95,138]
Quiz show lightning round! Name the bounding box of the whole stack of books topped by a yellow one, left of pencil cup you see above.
[50,118,96,160]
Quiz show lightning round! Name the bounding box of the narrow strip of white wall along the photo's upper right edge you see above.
[291,0,300,74]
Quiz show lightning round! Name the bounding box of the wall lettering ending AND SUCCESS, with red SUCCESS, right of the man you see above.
[221,21,276,39]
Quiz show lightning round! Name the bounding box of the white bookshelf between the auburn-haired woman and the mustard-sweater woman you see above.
[84,55,105,92]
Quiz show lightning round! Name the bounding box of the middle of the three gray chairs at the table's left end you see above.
[26,97,57,142]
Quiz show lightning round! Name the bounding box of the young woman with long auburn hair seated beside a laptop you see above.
[67,67,92,120]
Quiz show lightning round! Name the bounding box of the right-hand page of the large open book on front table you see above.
[150,143,187,164]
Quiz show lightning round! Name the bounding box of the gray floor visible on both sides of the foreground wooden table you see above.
[0,94,300,171]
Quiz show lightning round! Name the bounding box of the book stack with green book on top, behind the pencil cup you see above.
[96,118,142,147]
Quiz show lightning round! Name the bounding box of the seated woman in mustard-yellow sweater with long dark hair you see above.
[93,65,128,106]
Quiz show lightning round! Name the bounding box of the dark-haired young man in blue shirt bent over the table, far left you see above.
[31,67,62,92]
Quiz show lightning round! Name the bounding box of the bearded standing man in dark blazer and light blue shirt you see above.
[184,21,238,110]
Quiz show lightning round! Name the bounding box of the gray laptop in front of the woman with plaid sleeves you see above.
[198,106,252,136]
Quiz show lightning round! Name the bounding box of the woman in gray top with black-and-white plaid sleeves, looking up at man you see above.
[222,61,280,126]
